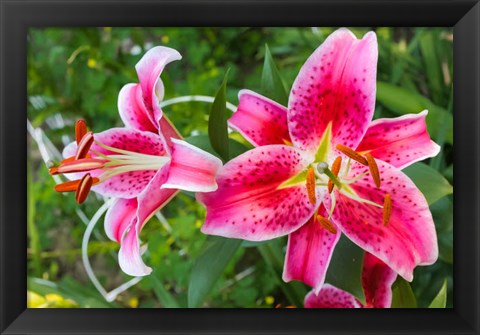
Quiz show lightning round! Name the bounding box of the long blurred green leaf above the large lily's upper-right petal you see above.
[377,81,453,144]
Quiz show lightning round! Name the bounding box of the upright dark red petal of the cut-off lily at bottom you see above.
[362,252,397,308]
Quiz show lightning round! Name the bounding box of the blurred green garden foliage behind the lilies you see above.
[27,27,453,307]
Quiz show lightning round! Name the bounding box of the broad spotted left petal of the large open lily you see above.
[197,145,316,241]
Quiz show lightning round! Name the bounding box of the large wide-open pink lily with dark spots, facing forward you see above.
[197,29,439,293]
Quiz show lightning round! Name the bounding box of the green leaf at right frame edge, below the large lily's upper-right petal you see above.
[403,163,453,205]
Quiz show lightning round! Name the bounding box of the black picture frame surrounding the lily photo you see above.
[0,0,480,334]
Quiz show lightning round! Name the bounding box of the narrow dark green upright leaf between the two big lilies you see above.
[208,69,230,162]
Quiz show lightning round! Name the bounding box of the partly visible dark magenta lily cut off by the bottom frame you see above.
[304,253,397,308]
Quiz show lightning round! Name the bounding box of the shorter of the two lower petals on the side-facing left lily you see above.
[104,198,137,243]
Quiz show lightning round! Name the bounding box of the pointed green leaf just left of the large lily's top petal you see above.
[262,44,288,106]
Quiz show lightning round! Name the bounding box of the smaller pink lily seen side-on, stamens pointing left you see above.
[51,47,222,276]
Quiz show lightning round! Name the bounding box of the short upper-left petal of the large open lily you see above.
[228,90,291,146]
